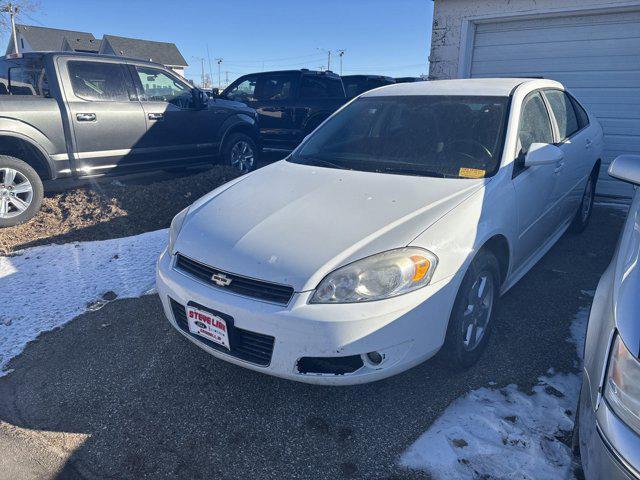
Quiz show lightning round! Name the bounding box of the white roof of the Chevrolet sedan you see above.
[362,78,562,97]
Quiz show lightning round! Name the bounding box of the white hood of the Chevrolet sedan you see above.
[175,161,485,291]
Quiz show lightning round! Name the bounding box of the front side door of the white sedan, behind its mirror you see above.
[513,91,558,266]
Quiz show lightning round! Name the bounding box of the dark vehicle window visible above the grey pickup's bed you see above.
[0,58,49,96]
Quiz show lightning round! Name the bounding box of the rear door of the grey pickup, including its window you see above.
[58,57,147,174]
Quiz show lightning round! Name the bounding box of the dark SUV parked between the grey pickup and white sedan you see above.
[220,69,346,150]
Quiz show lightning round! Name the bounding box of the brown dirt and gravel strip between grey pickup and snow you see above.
[0,165,238,255]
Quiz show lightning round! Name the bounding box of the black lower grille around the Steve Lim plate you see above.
[169,298,275,367]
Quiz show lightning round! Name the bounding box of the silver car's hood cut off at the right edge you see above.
[613,194,640,358]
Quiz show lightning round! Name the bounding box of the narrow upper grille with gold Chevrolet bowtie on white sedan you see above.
[176,254,293,305]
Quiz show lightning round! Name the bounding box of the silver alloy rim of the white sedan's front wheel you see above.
[462,271,495,351]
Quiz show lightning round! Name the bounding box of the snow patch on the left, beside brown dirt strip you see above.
[0,230,168,377]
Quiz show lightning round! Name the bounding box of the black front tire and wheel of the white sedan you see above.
[443,250,500,370]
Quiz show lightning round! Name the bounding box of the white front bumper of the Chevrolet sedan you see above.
[156,250,459,385]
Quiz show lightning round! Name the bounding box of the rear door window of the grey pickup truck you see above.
[67,61,129,102]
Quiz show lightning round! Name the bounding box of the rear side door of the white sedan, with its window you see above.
[544,89,594,224]
